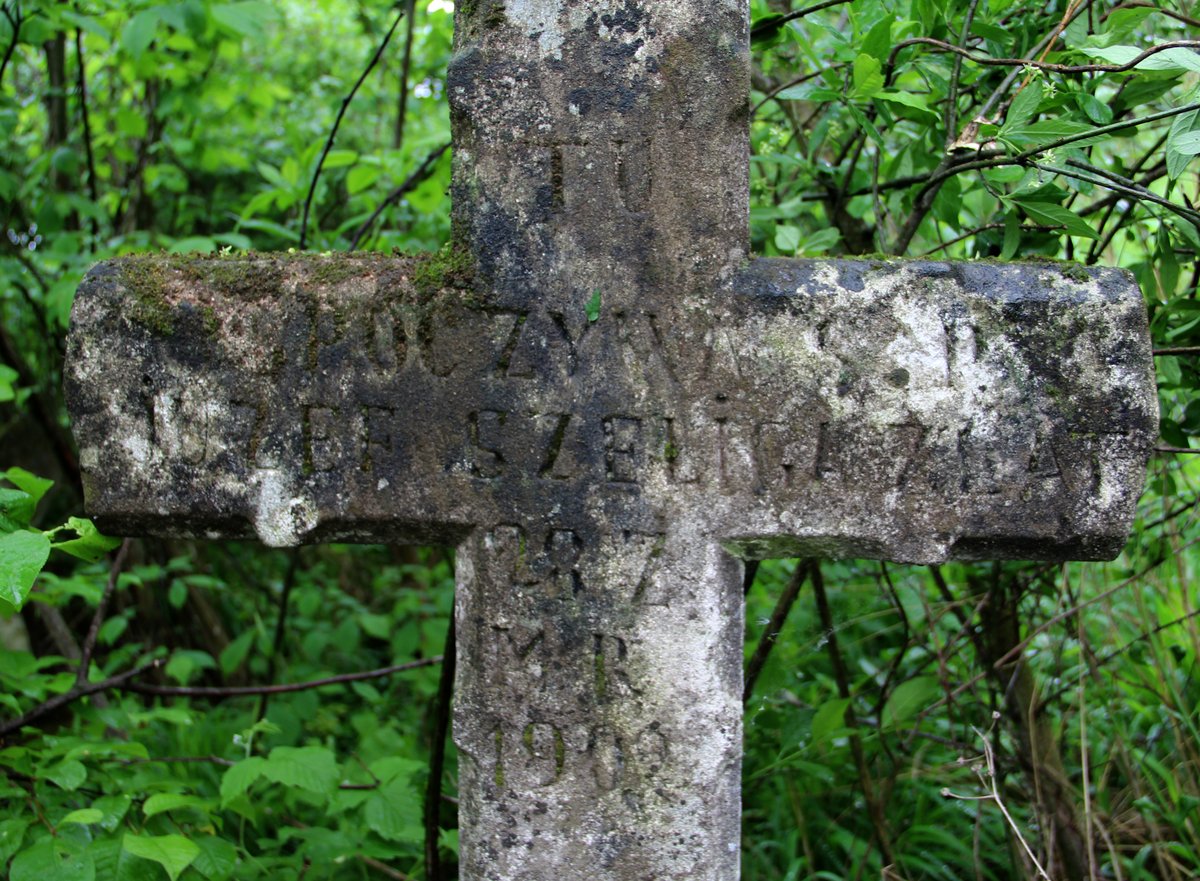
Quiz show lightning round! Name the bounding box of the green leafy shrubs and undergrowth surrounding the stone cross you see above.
[0,0,1200,881]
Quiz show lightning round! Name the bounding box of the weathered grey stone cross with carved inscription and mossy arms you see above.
[60,0,1157,881]
